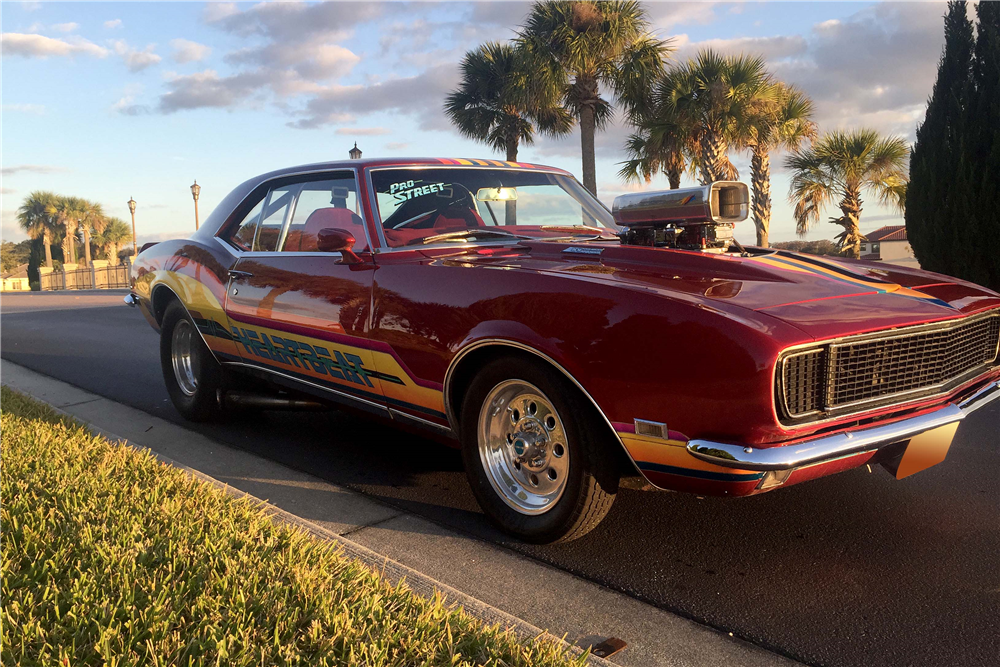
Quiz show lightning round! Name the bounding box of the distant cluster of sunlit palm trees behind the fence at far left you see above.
[17,191,132,270]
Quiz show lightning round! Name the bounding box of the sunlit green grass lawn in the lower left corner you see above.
[0,387,584,667]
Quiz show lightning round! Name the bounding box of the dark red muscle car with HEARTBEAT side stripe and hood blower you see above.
[126,159,1000,542]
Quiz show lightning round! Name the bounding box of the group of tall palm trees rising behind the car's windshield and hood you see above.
[445,0,909,257]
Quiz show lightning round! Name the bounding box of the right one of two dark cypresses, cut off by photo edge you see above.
[958,2,1000,291]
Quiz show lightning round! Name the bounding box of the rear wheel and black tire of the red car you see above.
[160,301,222,421]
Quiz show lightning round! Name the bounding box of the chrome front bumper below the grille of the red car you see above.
[687,382,1000,471]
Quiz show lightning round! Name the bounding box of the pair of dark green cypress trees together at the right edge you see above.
[906,2,1000,290]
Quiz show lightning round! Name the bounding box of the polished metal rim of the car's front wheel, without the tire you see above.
[478,380,569,514]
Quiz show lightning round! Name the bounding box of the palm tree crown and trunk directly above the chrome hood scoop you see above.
[650,49,776,183]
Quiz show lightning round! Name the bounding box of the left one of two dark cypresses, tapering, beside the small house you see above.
[906,0,975,275]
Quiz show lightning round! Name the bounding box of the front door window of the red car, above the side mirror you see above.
[282,174,368,252]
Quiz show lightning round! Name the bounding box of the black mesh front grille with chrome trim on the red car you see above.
[776,311,1000,421]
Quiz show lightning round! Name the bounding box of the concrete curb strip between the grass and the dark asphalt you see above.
[0,361,798,667]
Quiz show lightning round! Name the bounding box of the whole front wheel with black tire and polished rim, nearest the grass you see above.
[459,356,619,543]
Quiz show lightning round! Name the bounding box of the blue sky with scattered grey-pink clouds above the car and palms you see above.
[0,2,946,244]
